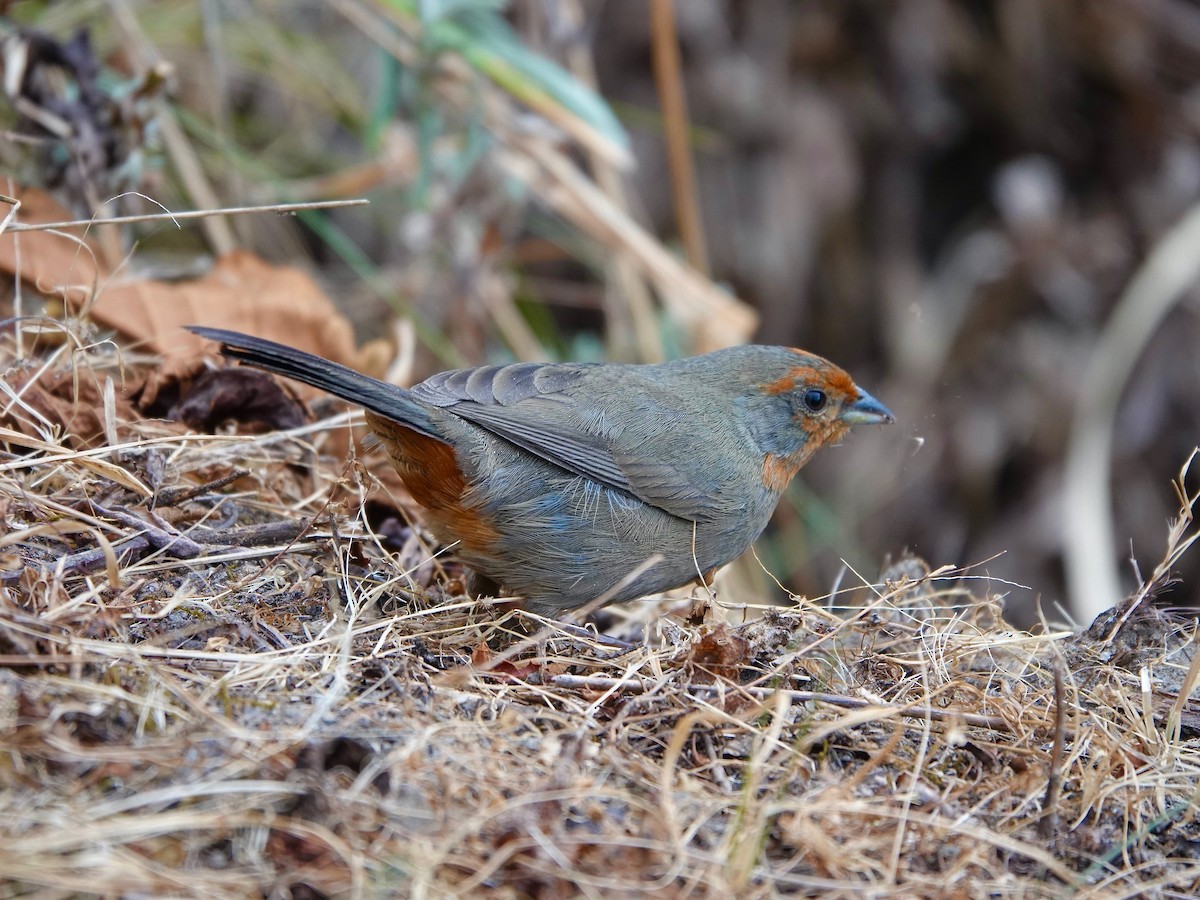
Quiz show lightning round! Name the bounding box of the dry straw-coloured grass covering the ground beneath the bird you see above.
[0,328,1200,896]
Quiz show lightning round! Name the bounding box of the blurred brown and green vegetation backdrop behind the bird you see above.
[0,0,1200,625]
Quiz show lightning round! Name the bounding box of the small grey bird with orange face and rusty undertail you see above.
[188,325,895,617]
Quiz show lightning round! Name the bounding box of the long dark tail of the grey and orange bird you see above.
[187,325,442,440]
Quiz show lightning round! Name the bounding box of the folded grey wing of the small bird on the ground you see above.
[413,364,715,521]
